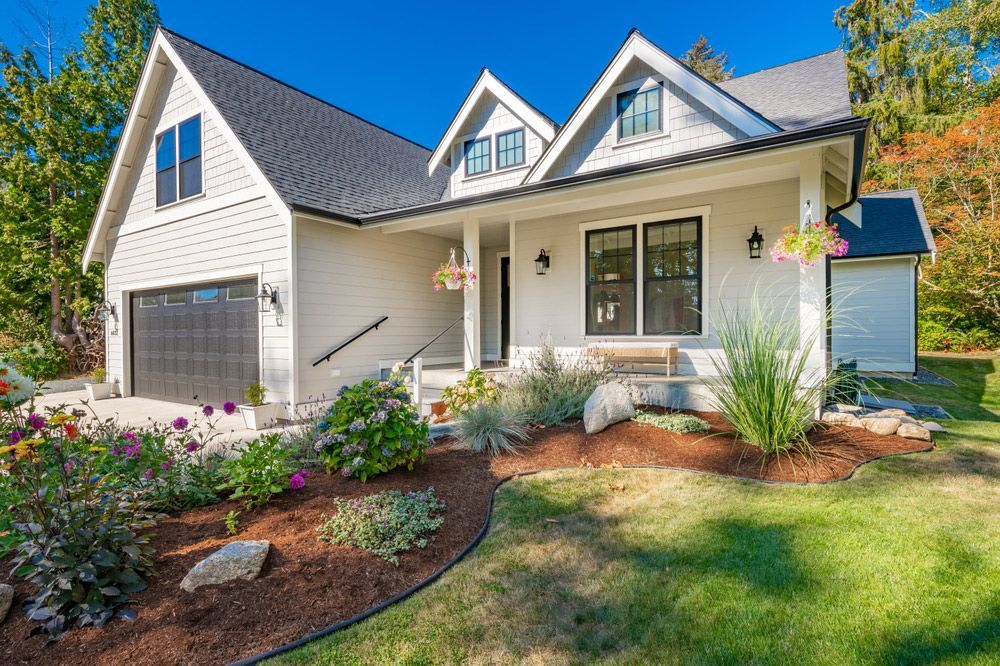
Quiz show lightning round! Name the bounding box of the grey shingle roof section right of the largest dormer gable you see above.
[718,50,853,130]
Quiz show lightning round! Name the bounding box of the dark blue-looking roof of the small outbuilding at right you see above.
[832,189,936,258]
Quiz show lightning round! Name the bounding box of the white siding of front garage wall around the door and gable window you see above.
[105,65,292,402]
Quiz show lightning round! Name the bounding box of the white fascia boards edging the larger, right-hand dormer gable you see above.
[523,33,781,184]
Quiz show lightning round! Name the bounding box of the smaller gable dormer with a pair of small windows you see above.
[428,69,556,198]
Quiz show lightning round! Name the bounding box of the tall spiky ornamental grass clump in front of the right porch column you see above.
[707,293,829,455]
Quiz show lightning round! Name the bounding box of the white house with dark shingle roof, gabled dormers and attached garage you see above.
[84,28,933,405]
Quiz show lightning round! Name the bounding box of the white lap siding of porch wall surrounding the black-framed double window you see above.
[512,180,799,374]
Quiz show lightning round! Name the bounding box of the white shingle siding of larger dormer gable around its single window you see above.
[549,61,747,178]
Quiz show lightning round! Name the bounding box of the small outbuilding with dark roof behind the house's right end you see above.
[831,189,936,373]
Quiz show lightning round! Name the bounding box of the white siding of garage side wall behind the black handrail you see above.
[296,218,463,400]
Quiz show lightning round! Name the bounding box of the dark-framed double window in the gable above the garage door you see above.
[156,115,202,207]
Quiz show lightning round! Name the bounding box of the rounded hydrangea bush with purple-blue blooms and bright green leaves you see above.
[315,376,430,482]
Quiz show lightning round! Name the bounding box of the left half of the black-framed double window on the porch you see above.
[587,227,636,335]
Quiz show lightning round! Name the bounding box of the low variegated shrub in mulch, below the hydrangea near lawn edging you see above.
[316,488,445,565]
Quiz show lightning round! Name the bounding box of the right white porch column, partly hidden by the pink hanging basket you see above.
[797,149,830,372]
